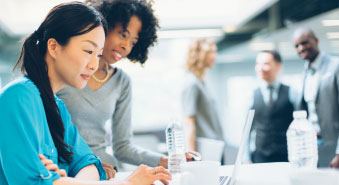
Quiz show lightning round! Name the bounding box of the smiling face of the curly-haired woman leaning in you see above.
[103,16,142,64]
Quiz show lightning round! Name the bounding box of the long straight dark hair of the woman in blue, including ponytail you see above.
[14,2,107,163]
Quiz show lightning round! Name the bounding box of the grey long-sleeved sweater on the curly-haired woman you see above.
[57,68,162,166]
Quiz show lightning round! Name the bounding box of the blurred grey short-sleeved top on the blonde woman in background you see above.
[181,73,224,141]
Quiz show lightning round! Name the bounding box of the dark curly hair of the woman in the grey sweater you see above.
[86,0,159,64]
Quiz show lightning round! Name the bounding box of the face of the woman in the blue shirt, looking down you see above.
[52,26,105,88]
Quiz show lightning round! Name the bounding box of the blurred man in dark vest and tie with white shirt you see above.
[250,51,294,163]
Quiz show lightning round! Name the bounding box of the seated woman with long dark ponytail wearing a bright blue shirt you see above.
[0,2,170,185]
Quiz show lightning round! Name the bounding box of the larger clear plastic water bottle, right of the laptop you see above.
[286,111,318,168]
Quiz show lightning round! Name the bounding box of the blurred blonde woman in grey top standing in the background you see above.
[181,38,224,163]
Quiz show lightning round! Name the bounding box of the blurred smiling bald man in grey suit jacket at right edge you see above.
[293,28,339,168]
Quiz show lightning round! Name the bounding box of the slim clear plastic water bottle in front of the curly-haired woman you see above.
[166,121,186,176]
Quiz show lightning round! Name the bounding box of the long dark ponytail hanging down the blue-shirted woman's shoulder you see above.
[14,30,73,163]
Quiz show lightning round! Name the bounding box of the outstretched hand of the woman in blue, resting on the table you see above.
[126,164,172,185]
